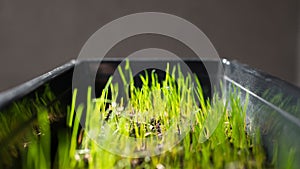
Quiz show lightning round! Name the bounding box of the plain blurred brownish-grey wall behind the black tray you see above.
[0,0,300,91]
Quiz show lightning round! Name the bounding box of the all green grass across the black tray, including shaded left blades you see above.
[0,62,292,169]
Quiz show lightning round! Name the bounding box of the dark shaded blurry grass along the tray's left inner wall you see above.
[0,85,63,168]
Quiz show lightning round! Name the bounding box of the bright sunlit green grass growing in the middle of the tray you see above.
[58,61,266,168]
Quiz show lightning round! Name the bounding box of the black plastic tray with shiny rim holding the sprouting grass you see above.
[0,59,300,168]
